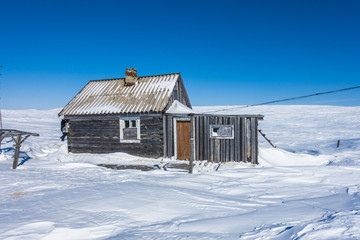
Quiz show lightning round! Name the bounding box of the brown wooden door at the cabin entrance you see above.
[176,121,190,160]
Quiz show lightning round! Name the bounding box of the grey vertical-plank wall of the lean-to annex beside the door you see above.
[164,115,258,164]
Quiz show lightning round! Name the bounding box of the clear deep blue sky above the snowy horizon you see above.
[0,0,360,109]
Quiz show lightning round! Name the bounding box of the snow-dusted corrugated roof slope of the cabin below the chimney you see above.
[59,73,180,116]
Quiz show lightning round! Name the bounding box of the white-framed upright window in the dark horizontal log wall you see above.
[119,117,140,143]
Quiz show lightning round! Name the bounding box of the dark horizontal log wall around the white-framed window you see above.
[68,115,164,157]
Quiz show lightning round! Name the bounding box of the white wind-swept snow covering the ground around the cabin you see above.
[0,106,360,240]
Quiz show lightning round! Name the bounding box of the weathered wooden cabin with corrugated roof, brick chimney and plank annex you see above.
[59,69,263,164]
